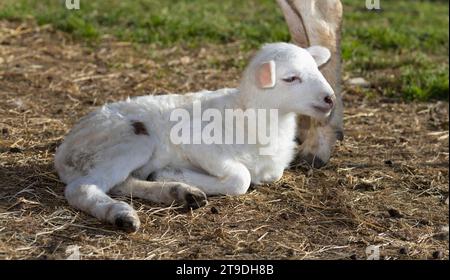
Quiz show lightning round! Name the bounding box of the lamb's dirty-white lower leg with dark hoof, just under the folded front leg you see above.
[111,176,207,209]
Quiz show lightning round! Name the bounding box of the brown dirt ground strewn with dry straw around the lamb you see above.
[0,21,449,259]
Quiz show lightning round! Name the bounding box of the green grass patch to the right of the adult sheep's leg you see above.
[343,0,449,101]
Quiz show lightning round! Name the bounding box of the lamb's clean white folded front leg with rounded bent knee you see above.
[153,162,251,195]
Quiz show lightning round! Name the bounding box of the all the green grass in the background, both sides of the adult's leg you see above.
[0,0,449,101]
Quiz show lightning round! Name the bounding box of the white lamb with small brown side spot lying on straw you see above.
[55,43,335,232]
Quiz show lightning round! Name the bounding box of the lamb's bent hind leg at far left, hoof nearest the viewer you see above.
[65,140,152,232]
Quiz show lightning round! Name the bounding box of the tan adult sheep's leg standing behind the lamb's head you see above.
[277,0,343,167]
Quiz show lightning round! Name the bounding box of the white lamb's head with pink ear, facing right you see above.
[240,43,336,120]
